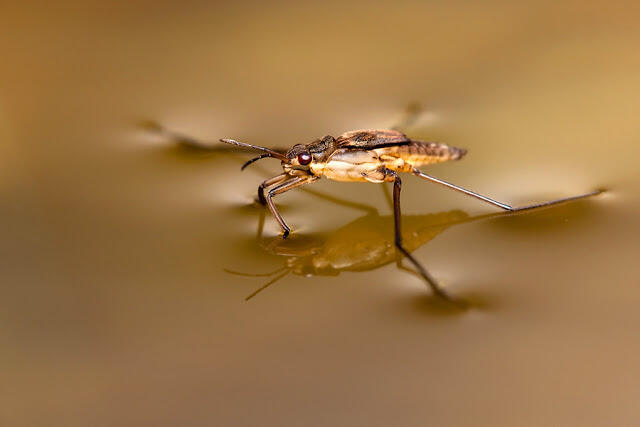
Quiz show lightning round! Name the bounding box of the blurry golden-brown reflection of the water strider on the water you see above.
[226,190,504,308]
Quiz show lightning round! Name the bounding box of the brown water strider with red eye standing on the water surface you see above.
[220,130,600,290]
